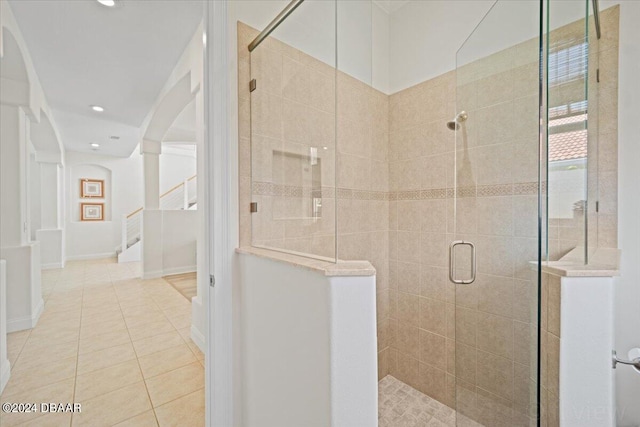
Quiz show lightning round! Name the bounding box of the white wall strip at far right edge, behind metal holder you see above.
[600,0,640,427]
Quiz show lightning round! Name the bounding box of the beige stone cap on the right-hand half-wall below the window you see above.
[531,246,621,277]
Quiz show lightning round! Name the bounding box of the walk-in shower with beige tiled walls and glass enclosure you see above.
[238,0,610,426]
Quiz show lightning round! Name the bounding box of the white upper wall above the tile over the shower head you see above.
[389,0,602,93]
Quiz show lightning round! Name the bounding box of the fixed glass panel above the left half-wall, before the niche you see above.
[251,0,336,260]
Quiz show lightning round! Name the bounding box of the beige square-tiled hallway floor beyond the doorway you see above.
[0,259,204,427]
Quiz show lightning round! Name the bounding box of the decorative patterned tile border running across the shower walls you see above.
[253,182,547,201]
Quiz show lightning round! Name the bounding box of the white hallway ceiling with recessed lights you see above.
[9,0,203,157]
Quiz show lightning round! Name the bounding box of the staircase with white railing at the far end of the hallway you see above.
[116,175,198,263]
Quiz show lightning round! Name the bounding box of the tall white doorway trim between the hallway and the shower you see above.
[203,0,238,427]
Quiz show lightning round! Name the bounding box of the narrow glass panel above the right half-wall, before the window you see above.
[545,0,597,262]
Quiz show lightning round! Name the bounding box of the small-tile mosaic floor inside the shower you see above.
[378,375,482,427]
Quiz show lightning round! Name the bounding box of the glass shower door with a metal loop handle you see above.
[452,1,541,426]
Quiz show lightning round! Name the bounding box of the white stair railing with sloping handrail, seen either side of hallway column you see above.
[120,175,197,252]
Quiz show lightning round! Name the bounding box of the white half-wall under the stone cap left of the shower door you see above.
[239,254,378,427]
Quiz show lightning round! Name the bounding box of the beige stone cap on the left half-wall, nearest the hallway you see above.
[236,246,376,276]
